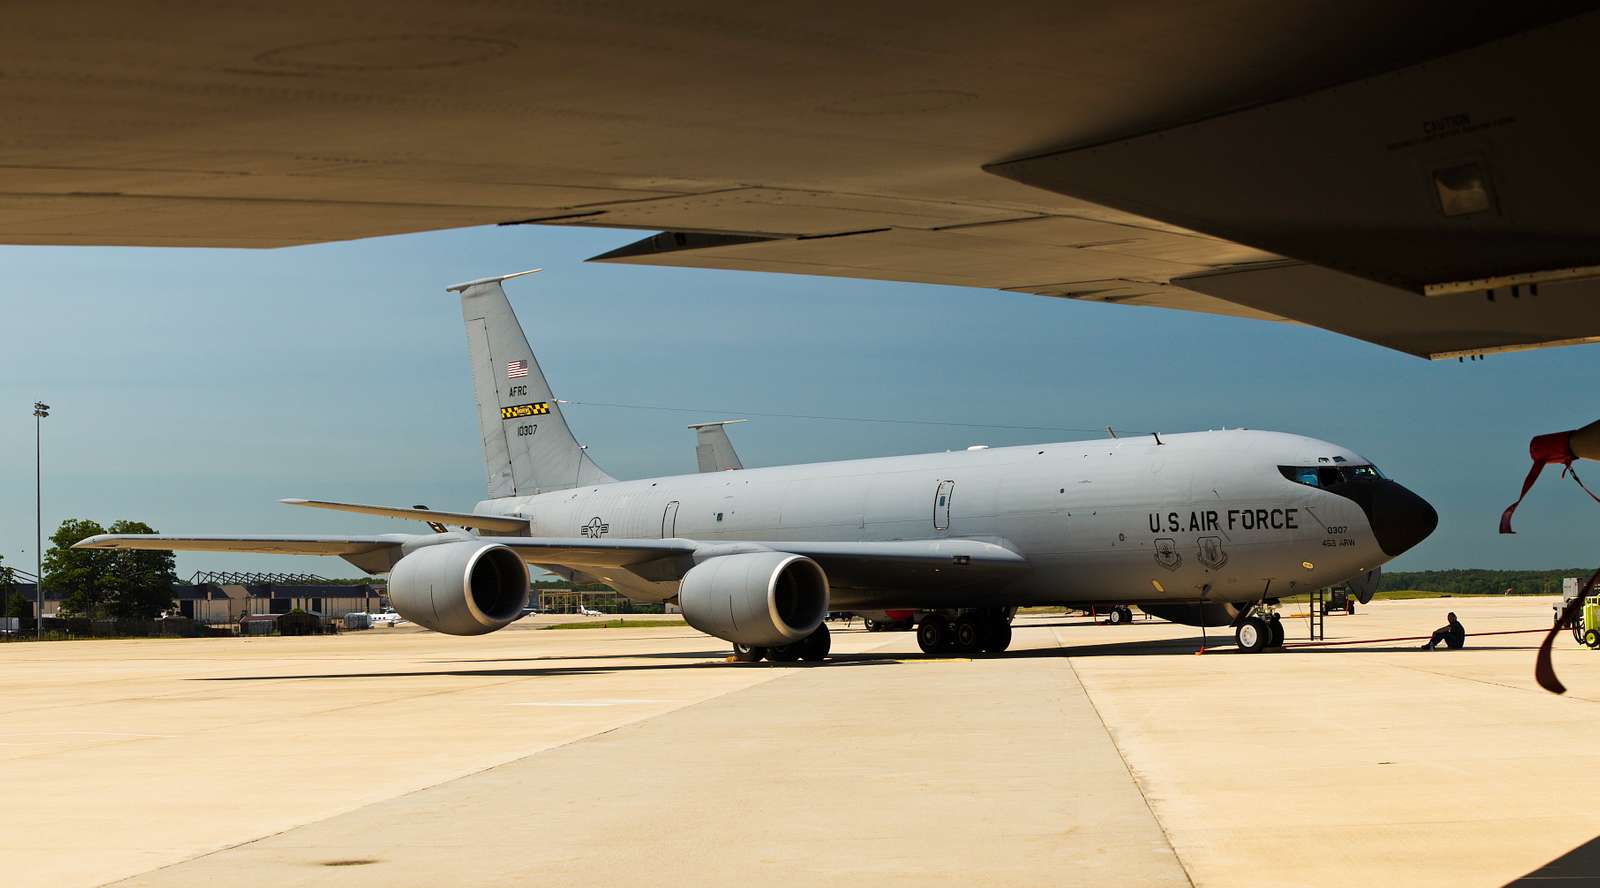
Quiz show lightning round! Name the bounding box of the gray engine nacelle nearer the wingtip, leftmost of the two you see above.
[389,541,528,635]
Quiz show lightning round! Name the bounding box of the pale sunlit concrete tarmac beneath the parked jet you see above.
[0,598,1600,888]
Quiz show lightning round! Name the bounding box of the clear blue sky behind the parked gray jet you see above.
[0,227,1600,578]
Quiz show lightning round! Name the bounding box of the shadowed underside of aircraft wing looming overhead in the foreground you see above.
[0,0,1600,357]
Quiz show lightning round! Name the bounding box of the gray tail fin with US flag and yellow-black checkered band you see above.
[450,269,616,499]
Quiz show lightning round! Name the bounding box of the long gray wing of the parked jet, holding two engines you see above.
[75,533,1027,587]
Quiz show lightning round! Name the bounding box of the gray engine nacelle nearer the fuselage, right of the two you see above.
[678,552,827,648]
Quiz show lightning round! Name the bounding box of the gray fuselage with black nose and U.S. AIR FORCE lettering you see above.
[475,430,1437,608]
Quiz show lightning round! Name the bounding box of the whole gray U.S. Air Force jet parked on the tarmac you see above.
[78,269,1438,662]
